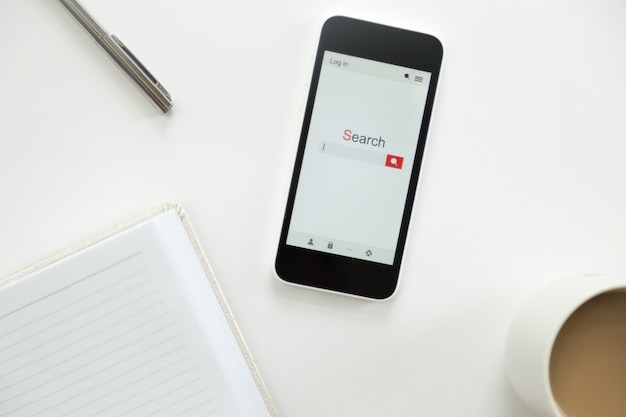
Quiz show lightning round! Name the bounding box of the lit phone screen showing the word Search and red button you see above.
[286,50,431,265]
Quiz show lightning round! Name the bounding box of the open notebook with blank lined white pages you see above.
[0,204,278,417]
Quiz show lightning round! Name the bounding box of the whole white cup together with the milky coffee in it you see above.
[505,274,626,417]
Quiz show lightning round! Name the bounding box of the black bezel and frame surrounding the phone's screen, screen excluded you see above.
[274,16,443,299]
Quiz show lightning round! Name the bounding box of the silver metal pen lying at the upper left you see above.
[59,0,172,113]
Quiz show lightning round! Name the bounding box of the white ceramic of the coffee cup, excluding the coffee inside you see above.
[505,274,626,417]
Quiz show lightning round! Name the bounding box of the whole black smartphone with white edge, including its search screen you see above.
[275,16,443,299]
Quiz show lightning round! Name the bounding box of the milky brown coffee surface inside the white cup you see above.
[550,289,626,417]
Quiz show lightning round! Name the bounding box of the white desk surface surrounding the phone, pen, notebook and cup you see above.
[0,0,626,417]
